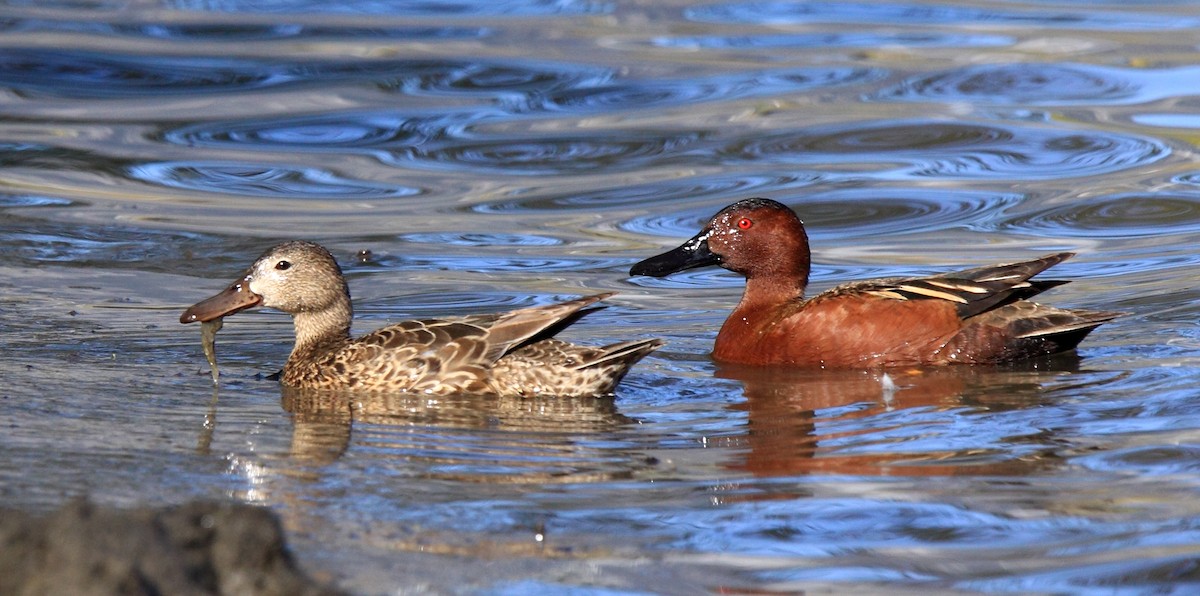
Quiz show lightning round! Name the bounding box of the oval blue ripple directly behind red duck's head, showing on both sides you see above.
[620,188,1022,241]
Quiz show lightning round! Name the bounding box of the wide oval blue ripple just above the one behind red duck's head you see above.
[721,121,1170,179]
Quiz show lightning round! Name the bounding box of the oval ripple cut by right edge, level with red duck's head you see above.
[996,192,1200,239]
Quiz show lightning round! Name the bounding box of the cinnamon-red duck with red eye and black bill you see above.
[630,198,1122,368]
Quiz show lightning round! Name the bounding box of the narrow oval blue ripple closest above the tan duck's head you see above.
[128,162,421,199]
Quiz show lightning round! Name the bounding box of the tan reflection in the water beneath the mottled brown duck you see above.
[282,387,649,483]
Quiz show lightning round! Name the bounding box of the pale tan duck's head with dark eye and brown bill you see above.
[179,241,349,323]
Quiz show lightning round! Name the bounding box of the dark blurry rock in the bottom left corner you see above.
[0,500,340,596]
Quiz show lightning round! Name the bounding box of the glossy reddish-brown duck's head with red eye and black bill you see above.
[629,198,809,281]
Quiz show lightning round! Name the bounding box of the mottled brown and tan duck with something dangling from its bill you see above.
[179,241,662,397]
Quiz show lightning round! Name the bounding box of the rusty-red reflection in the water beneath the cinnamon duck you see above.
[716,354,1079,477]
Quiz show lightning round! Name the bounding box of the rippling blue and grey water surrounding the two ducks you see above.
[0,0,1200,594]
